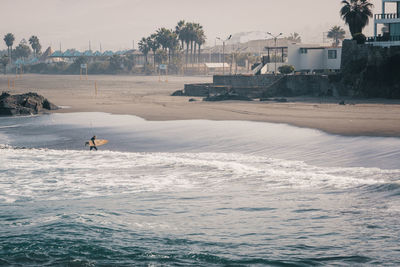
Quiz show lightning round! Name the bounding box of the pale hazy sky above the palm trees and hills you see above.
[0,0,381,51]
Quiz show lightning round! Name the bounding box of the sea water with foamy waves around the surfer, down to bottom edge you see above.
[0,113,400,266]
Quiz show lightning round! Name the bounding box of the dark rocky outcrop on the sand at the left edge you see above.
[0,92,58,116]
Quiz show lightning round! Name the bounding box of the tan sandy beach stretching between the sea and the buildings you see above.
[0,74,400,137]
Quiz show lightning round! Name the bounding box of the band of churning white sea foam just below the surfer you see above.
[0,147,400,202]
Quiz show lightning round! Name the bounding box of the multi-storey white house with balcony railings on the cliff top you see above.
[367,0,400,47]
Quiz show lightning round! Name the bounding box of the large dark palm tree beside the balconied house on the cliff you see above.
[340,0,374,37]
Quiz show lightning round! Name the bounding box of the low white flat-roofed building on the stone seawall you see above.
[288,44,342,72]
